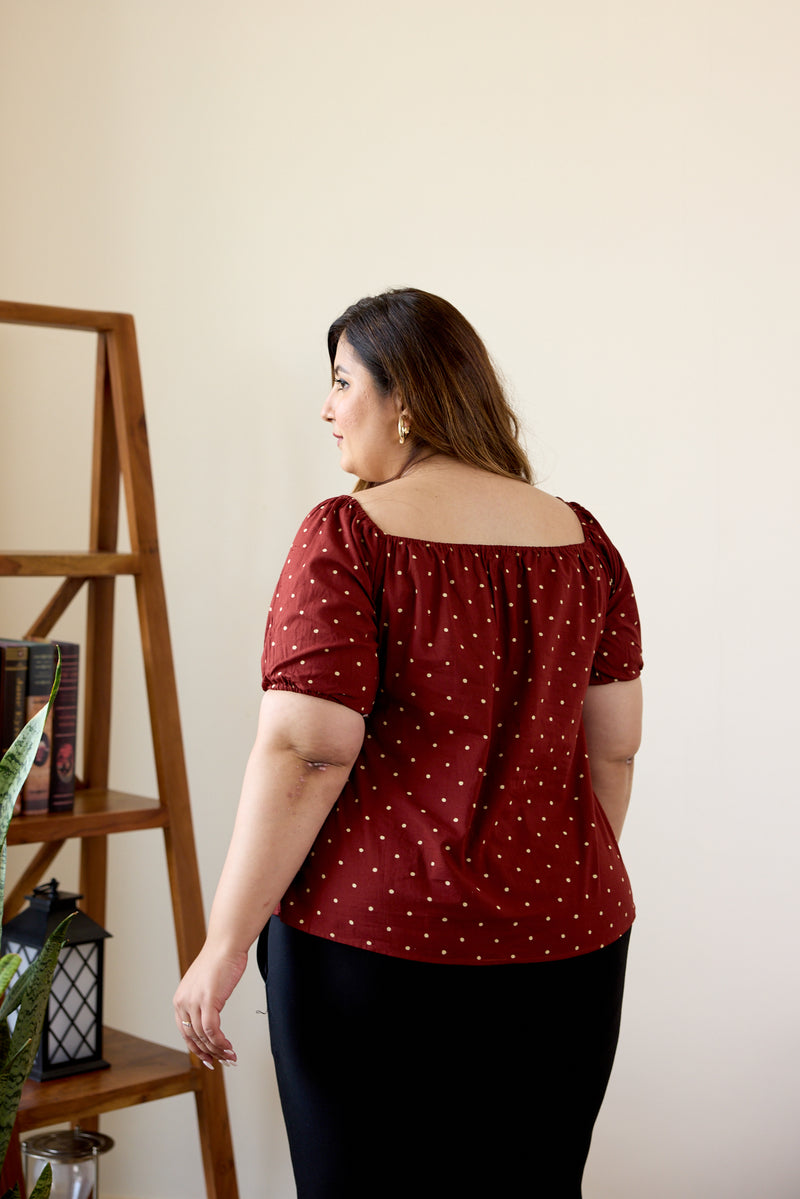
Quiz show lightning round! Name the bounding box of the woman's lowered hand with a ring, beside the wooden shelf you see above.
[173,941,247,1070]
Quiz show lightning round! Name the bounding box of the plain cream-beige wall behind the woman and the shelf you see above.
[0,0,800,1199]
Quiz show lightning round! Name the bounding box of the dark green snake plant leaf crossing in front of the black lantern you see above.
[0,916,72,1162]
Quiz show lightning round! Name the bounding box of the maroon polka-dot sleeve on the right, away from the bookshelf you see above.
[582,508,643,683]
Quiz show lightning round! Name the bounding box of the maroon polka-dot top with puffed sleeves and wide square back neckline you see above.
[261,495,642,963]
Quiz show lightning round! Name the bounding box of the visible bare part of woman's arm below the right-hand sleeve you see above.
[583,679,642,839]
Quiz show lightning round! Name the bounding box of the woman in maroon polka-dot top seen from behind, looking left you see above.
[175,289,640,1199]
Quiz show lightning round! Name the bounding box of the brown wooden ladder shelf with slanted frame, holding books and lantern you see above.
[0,301,239,1199]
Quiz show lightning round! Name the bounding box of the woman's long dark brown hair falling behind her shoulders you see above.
[327,288,533,490]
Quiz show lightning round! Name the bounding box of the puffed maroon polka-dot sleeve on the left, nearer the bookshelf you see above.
[261,496,379,716]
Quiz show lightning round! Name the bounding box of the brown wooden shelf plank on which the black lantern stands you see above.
[18,1029,201,1133]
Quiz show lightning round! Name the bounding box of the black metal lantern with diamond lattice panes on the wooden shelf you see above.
[2,879,112,1081]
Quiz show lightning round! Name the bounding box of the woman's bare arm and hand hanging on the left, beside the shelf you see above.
[174,691,365,1067]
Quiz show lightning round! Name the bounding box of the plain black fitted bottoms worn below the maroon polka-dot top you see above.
[259,917,630,1199]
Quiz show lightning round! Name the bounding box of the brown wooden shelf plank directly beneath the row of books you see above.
[8,790,169,845]
